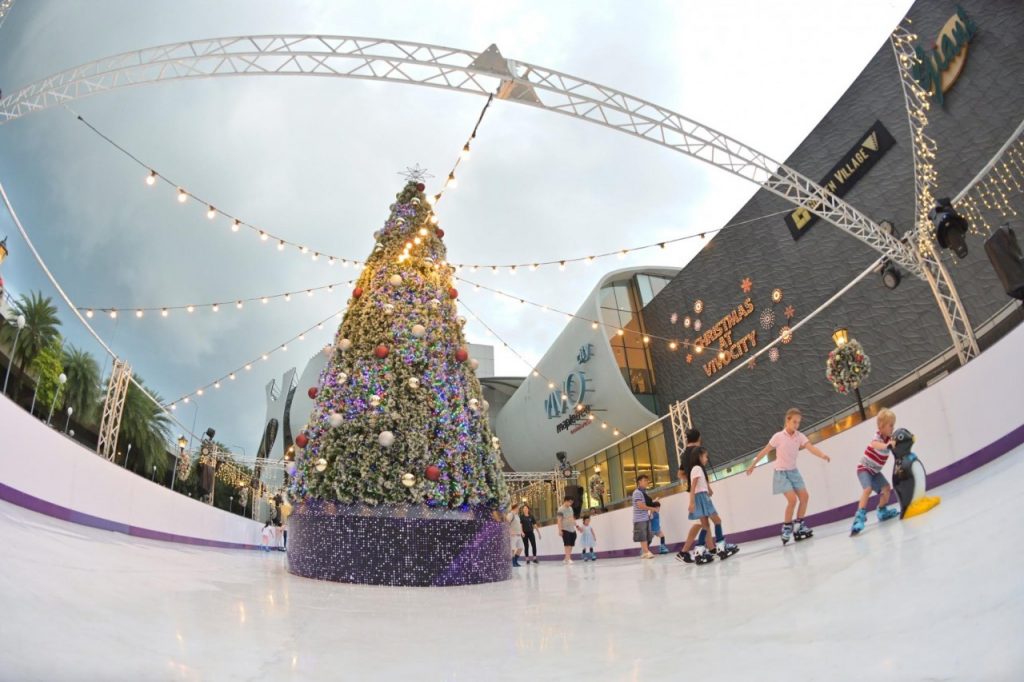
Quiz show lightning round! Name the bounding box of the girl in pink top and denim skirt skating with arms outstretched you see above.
[746,408,831,545]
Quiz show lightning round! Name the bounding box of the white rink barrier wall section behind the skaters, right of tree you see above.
[538,315,1024,560]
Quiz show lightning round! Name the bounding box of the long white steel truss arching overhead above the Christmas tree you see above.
[0,35,976,361]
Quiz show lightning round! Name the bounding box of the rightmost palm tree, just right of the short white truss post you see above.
[118,376,172,477]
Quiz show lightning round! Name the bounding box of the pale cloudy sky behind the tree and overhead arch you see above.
[0,0,910,458]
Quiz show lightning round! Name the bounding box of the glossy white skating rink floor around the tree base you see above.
[0,438,1024,682]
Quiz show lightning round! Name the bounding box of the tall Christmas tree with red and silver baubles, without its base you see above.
[292,178,508,509]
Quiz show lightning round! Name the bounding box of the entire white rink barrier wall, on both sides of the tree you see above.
[0,317,1024,559]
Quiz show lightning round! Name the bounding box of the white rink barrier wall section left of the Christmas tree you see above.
[0,395,262,549]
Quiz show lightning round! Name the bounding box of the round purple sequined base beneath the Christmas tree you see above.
[288,501,512,587]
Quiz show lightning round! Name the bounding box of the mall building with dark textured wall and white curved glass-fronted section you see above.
[495,2,1024,518]
